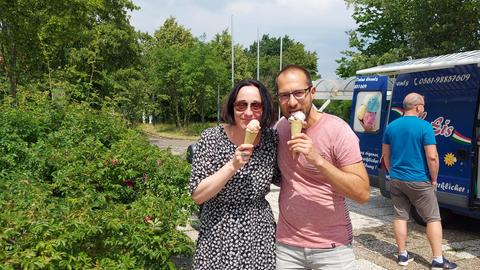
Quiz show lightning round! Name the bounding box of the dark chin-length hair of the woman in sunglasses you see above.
[222,79,275,127]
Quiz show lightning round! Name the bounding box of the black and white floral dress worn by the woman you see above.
[190,126,280,270]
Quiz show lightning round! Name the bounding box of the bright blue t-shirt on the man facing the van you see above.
[383,116,437,181]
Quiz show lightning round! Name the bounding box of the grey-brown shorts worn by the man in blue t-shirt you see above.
[390,179,441,223]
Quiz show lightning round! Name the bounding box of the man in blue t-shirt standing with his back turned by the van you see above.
[382,93,457,269]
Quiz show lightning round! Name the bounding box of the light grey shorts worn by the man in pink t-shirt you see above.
[275,242,357,270]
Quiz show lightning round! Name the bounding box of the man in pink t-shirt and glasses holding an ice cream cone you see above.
[276,65,370,269]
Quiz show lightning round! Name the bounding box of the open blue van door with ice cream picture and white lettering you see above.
[350,76,389,181]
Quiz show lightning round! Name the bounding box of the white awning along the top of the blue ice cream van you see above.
[357,50,480,75]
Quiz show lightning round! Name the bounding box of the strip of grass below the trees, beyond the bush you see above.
[138,123,217,140]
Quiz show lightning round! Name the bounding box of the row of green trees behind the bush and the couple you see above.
[0,3,317,124]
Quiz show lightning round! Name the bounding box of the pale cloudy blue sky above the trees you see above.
[130,0,355,79]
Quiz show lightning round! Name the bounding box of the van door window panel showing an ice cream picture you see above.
[353,91,383,133]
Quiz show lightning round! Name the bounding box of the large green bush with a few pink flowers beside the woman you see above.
[0,90,194,269]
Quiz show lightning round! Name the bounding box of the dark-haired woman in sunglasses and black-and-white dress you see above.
[190,80,280,270]
